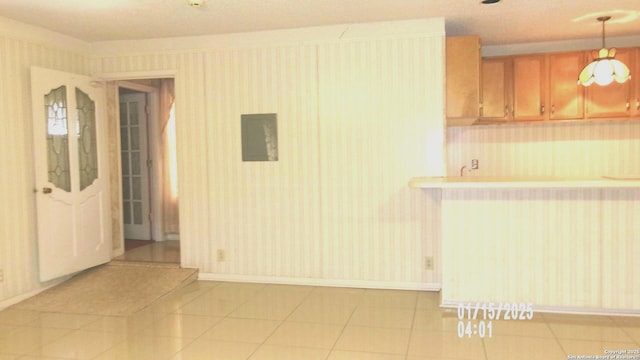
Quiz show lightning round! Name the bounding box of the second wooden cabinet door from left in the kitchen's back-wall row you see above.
[513,55,547,121]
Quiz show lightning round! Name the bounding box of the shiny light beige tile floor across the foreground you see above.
[0,281,640,360]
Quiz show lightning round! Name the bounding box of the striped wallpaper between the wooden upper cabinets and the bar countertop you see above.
[447,121,640,176]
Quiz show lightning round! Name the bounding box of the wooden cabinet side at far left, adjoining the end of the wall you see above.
[446,36,481,126]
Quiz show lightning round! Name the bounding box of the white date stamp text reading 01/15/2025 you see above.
[458,302,533,320]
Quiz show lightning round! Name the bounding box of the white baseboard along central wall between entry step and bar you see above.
[198,273,441,291]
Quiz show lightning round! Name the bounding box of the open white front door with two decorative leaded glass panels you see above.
[31,67,112,281]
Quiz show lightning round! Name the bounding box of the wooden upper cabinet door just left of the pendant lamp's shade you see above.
[549,51,585,120]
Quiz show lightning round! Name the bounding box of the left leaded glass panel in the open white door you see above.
[44,86,71,192]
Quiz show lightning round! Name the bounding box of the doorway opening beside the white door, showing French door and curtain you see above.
[112,79,180,263]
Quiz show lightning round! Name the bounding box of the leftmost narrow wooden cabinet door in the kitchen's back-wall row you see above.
[481,57,513,121]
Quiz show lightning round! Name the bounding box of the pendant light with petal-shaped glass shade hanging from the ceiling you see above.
[578,16,631,86]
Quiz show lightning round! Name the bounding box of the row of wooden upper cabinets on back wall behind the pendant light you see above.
[460,48,640,123]
